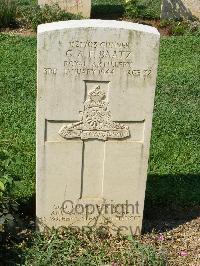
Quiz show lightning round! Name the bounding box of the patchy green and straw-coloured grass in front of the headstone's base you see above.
[10,225,166,266]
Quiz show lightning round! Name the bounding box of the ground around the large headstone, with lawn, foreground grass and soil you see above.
[0,0,200,266]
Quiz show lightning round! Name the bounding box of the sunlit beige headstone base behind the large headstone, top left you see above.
[38,0,91,18]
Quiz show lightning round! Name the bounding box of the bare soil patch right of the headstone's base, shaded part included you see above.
[139,206,200,266]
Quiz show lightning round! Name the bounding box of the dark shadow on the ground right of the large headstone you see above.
[143,174,200,233]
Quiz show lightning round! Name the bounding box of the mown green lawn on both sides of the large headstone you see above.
[0,34,200,206]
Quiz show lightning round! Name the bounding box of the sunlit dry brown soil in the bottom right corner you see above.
[140,217,200,266]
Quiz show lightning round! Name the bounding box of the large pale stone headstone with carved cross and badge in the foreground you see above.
[37,20,159,234]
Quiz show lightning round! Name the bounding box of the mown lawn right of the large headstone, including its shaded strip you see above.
[146,36,200,206]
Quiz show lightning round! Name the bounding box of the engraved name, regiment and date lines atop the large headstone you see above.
[44,40,153,80]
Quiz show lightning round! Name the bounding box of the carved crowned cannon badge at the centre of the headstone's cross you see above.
[58,86,130,141]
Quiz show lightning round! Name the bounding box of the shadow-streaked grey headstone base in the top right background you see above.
[161,0,194,19]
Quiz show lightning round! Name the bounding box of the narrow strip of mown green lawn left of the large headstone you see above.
[0,34,36,198]
